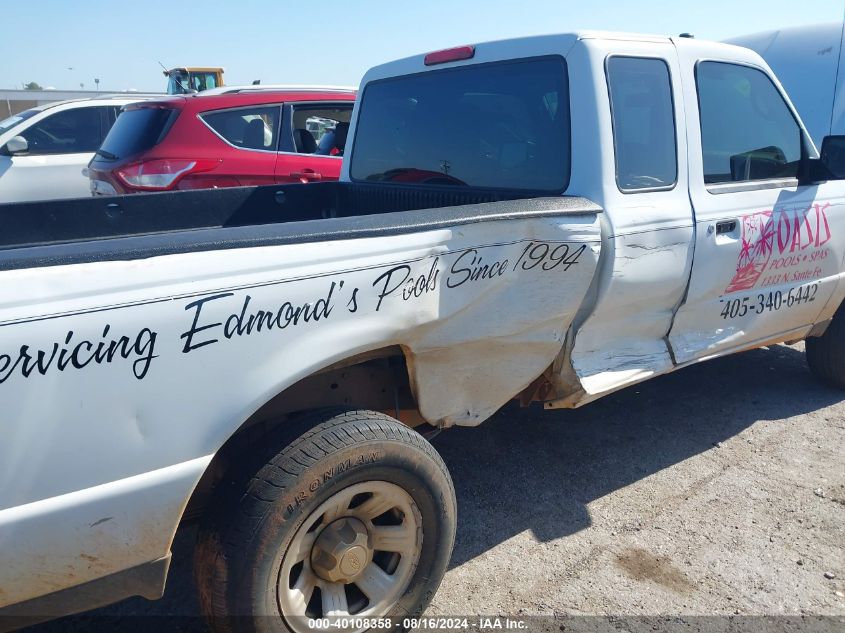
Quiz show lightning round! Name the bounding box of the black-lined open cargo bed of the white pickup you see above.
[0,182,600,270]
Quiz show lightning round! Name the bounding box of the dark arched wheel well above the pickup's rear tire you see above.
[182,346,425,523]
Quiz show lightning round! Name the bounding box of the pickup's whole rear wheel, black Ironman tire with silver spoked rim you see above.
[195,411,456,633]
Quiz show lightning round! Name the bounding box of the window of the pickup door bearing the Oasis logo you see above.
[696,62,801,183]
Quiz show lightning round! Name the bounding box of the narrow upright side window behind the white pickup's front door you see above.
[607,57,678,191]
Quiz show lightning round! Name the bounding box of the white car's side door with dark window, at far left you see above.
[0,106,109,202]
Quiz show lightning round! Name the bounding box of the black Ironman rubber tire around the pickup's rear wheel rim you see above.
[194,411,457,633]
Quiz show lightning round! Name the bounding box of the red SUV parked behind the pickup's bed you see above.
[88,86,355,195]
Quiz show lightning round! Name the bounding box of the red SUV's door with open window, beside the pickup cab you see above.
[276,101,354,183]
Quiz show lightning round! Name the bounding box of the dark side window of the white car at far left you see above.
[20,107,103,156]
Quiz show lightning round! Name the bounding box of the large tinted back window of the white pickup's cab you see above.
[350,57,570,192]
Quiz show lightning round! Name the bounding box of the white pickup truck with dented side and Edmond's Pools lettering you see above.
[0,33,845,631]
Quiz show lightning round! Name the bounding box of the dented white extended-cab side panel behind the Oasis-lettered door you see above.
[547,35,693,408]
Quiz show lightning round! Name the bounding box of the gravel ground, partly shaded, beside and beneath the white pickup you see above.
[19,345,845,633]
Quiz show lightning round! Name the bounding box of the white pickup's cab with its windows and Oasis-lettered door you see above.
[342,33,845,406]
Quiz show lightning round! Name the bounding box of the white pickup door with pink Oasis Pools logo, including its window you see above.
[669,44,845,363]
